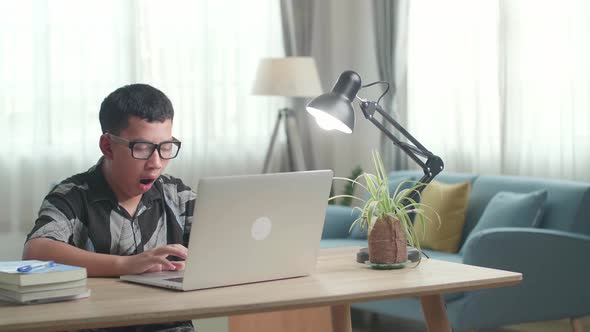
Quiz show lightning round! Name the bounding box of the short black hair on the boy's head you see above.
[98,84,174,135]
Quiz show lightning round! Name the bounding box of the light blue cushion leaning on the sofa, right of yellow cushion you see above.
[465,189,547,254]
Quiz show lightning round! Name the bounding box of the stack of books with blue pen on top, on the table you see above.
[0,260,90,304]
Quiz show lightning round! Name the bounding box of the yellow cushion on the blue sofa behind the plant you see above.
[414,180,471,253]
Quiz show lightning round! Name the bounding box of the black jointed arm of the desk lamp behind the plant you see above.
[360,100,444,203]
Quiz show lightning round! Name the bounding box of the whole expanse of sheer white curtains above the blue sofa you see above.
[408,0,590,180]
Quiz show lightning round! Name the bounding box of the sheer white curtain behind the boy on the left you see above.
[0,0,286,233]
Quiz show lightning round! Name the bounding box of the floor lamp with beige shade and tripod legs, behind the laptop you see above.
[252,57,323,173]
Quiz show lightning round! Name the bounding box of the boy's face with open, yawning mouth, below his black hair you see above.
[111,116,172,198]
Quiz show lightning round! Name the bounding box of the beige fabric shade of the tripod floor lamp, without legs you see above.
[252,57,323,97]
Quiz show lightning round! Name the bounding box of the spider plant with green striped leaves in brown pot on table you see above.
[330,151,438,268]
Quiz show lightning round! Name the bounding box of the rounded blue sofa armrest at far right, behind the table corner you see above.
[460,227,590,328]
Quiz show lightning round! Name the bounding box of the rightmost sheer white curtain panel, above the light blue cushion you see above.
[501,0,590,181]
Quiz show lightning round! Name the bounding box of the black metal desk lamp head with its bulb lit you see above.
[306,71,361,134]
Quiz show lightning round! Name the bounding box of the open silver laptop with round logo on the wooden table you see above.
[121,170,333,291]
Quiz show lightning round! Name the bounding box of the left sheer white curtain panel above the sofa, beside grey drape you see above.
[407,0,501,173]
